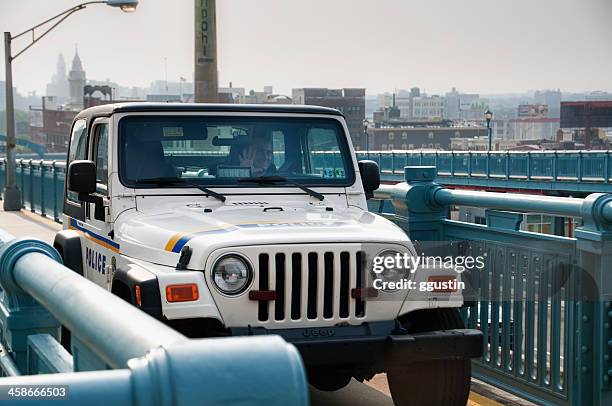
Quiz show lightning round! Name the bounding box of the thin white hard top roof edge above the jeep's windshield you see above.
[76,102,342,119]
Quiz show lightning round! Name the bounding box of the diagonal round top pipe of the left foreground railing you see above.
[13,252,187,368]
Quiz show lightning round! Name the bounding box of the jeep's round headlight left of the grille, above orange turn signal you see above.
[212,254,253,295]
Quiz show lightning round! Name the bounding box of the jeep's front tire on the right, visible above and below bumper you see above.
[387,309,472,406]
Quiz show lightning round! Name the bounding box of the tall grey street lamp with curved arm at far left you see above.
[3,0,138,211]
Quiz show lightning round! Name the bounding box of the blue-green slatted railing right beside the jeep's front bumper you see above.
[371,167,612,405]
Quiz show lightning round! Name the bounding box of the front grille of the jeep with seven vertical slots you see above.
[257,251,366,322]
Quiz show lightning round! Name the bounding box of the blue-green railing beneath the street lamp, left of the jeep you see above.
[0,158,66,222]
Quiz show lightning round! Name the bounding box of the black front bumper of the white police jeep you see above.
[231,321,483,371]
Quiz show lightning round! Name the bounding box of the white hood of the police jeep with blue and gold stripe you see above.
[115,205,409,269]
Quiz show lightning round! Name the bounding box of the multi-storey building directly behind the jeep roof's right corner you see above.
[292,88,366,149]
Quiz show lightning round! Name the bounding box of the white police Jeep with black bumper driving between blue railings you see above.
[54,103,482,404]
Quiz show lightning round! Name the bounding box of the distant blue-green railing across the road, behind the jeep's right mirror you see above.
[357,151,612,192]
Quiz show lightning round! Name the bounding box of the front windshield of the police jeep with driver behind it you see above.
[119,115,355,188]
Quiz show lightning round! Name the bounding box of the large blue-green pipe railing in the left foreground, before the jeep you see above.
[0,231,308,406]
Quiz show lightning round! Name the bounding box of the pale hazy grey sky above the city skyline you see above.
[0,0,612,94]
